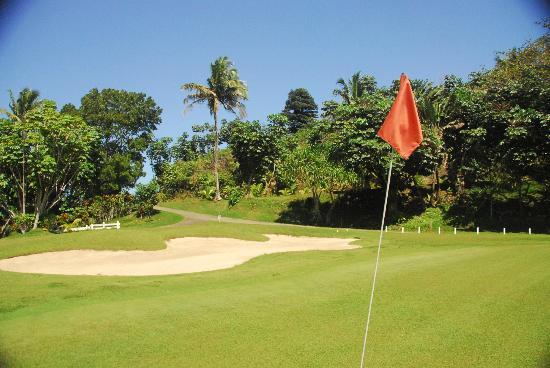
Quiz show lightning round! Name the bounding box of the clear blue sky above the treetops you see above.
[0,0,549,178]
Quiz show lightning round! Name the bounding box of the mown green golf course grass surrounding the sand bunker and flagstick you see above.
[0,217,550,368]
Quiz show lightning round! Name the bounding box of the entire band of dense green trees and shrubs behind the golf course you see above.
[0,28,550,235]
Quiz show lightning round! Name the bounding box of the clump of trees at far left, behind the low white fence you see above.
[0,88,162,236]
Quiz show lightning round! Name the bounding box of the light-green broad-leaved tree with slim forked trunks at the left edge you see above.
[0,101,98,228]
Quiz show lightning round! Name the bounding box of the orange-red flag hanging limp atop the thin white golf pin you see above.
[378,74,422,159]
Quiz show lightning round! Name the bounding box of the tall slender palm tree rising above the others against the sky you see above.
[181,56,248,201]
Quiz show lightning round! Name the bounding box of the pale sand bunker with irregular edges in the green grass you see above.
[0,235,358,276]
